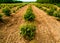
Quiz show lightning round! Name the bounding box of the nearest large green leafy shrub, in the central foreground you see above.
[20,24,36,40]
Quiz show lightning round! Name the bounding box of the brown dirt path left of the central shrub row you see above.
[0,6,28,43]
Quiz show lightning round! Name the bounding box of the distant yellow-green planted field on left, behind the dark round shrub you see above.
[0,3,27,13]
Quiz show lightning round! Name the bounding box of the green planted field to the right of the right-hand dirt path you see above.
[35,3,60,20]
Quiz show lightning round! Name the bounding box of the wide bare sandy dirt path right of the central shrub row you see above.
[32,6,60,43]
